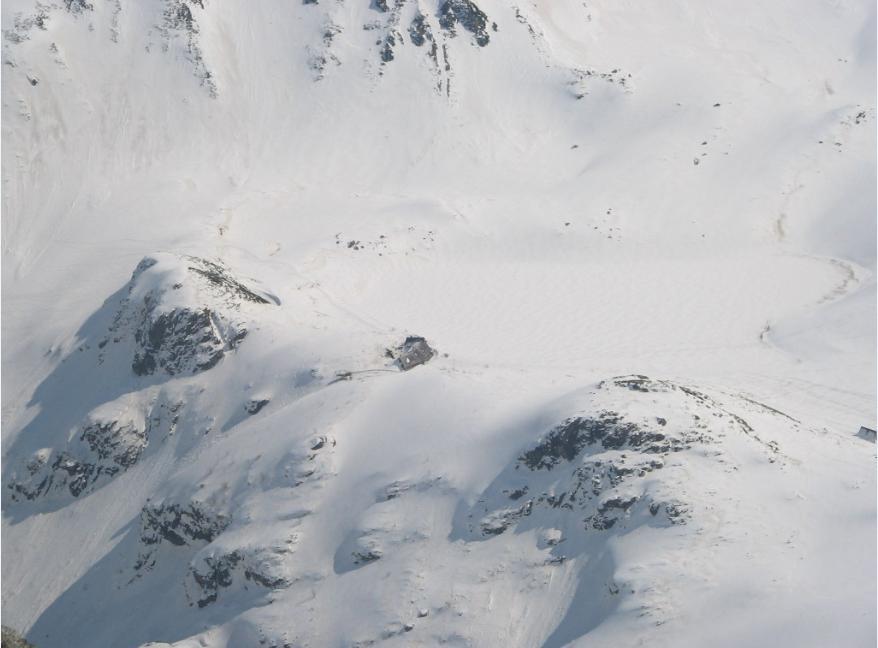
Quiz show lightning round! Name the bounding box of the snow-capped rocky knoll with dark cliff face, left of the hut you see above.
[100,254,270,376]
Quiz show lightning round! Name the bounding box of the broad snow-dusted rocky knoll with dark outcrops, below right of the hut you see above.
[460,376,778,538]
